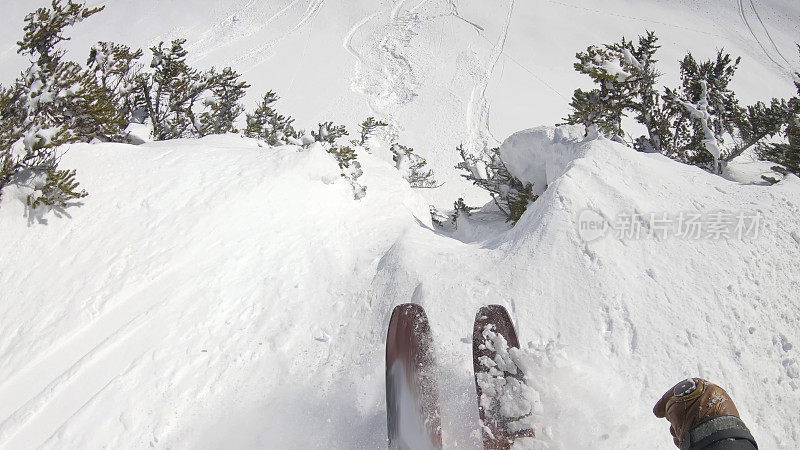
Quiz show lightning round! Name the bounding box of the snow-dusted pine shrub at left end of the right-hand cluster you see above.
[564,32,669,151]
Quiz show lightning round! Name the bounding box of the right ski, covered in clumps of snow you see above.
[472,305,534,450]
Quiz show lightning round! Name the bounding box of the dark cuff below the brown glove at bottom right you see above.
[681,416,758,450]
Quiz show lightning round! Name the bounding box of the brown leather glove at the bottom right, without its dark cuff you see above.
[653,378,739,448]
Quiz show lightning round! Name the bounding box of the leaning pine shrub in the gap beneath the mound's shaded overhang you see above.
[456,144,538,223]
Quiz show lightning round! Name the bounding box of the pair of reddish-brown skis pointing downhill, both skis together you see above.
[386,303,533,450]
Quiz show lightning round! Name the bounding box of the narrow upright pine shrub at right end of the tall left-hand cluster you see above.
[199,67,250,135]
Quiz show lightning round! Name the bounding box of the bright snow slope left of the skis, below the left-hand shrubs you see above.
[0,137,430,448]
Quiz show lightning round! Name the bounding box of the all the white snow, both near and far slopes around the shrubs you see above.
[0,0,800,449]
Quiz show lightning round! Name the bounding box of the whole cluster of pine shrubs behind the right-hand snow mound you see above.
[565,32,789,172]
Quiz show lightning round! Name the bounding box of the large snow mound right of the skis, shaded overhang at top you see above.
[497,128,800,448]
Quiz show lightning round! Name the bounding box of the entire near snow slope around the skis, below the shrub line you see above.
[0,128,800,449]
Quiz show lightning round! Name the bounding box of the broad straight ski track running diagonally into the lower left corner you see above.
[0,266,190,448]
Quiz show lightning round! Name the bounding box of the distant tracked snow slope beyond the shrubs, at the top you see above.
[0,0,800,207]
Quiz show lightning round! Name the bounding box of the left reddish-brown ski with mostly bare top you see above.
[386,303,442,450]
